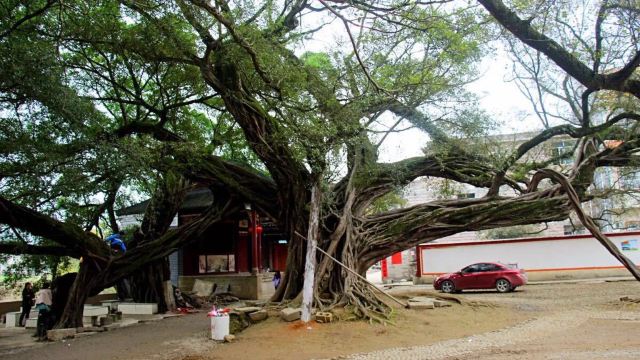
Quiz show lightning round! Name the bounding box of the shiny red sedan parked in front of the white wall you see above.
[433,263,527,293]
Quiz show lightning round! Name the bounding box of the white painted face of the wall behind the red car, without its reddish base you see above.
[421,234,640,275]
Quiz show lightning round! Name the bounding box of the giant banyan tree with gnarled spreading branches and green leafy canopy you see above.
[0,0,640,327]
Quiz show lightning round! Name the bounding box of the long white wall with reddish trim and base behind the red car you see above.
[419,232,640,283]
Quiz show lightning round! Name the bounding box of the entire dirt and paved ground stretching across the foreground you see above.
[0,281,640,360]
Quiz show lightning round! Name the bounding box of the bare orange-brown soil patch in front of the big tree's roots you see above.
[203,305,526,360]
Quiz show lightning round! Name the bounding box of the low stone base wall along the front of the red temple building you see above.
[178,273,275,300]
